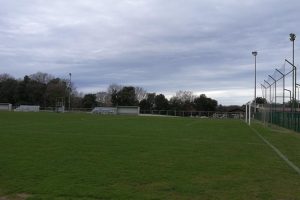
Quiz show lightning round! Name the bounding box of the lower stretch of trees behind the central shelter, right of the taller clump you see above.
[84,84,218,111]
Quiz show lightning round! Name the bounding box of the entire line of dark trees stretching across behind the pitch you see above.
[0,72,240,111]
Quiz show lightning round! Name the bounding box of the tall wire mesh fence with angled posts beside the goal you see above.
[255,60,300,131]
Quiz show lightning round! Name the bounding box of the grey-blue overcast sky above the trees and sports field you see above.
[0,0,300,105]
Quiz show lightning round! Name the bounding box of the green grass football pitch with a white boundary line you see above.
[0,112,300,200]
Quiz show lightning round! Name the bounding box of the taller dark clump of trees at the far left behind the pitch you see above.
[0,73,67,107]
